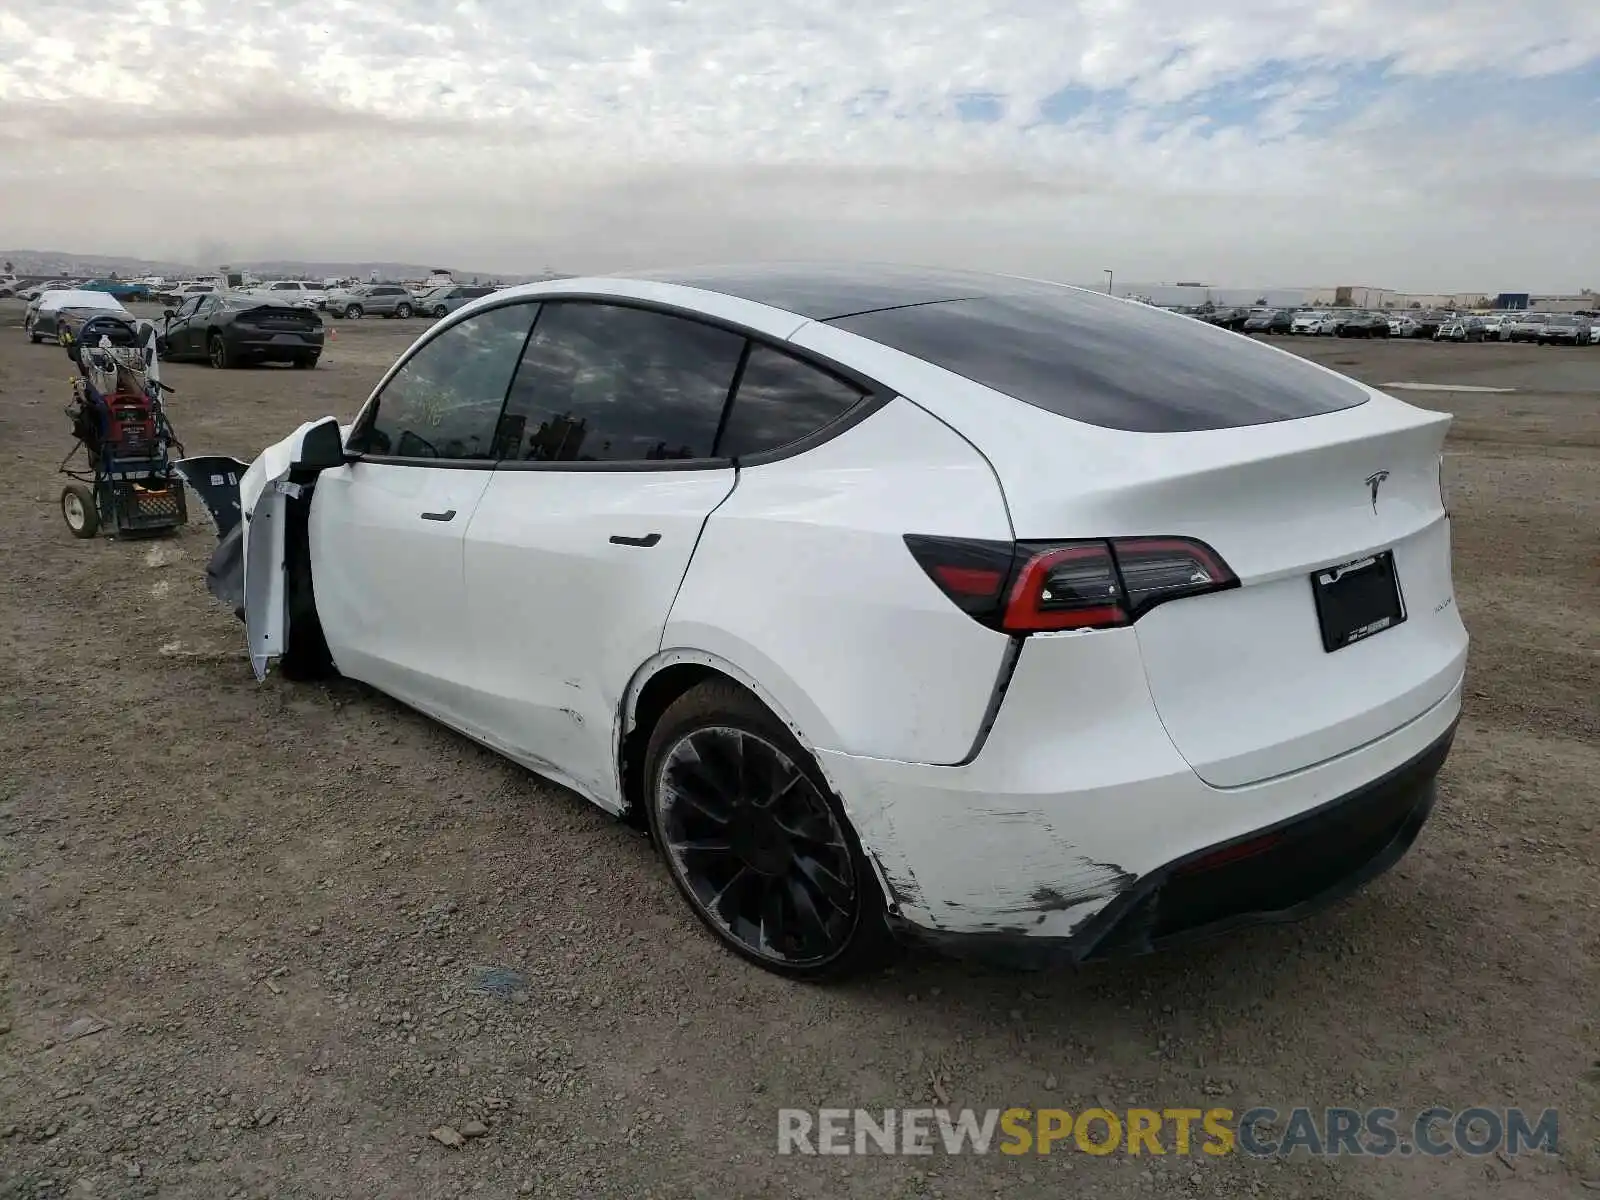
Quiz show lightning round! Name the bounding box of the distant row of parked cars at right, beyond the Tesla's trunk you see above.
[1174,309,1600,346]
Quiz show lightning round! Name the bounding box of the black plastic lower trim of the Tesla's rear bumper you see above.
[894,723,1456,968]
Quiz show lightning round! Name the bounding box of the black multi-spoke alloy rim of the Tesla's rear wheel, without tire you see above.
[656,725,861,966]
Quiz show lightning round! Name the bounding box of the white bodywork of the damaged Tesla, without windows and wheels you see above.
[178,267,1466,960]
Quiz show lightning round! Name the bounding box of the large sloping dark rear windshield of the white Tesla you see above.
[829,282,1366,434]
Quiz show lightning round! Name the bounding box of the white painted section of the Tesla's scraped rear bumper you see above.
[818,630,1461,957]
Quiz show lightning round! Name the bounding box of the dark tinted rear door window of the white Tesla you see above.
[501,302,744,462]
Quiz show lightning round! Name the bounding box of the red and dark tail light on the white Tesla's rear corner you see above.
[906,534,1238,634]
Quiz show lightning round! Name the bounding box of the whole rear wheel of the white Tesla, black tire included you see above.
[643,680,894,981]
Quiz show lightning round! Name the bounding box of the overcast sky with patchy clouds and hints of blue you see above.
[0,0,1600,293]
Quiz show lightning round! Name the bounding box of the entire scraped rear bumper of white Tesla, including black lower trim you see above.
[816,629,1461,960]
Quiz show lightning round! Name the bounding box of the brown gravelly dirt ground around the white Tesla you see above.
[0,306,1600,1200]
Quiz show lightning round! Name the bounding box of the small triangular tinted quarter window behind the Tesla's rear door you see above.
[717,346,864,458]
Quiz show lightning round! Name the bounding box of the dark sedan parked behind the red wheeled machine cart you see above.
[162,291,323,368]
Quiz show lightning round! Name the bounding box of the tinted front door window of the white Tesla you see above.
[352,304,538,459]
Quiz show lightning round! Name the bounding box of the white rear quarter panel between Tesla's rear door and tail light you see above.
[662,398,1011,764]
